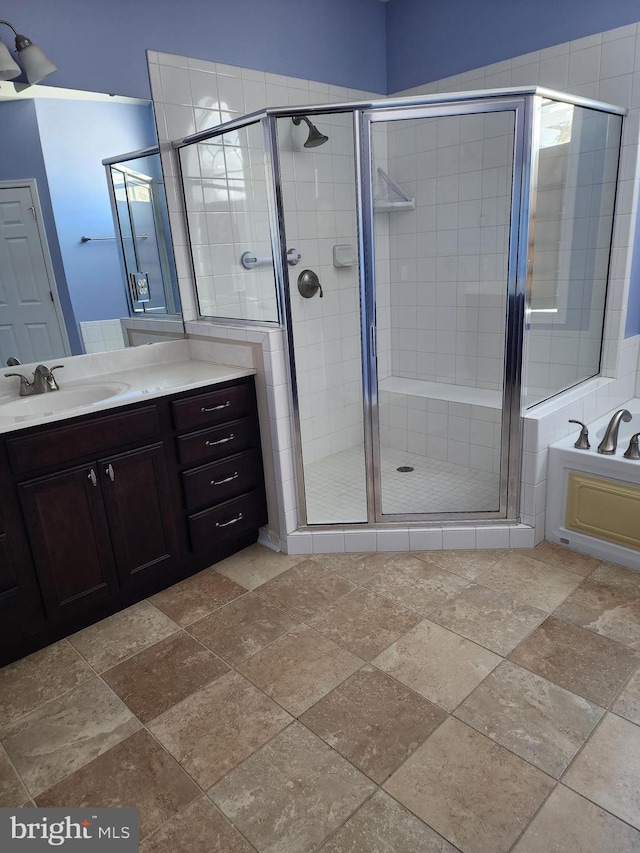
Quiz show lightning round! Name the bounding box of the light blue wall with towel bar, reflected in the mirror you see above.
[36,99,155,330]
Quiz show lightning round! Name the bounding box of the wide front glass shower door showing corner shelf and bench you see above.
[366,105,516,520]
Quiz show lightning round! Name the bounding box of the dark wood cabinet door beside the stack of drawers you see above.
[98,443,177,586]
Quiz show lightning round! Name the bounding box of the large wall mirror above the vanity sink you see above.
[0,82,184,365]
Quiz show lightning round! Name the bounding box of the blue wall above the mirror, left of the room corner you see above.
[1,0,387,98]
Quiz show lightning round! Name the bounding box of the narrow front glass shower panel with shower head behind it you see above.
[277,113,368,524]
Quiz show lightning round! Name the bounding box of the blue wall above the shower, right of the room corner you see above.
[386,0,640,92]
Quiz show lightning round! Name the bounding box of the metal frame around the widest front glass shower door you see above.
[354,95,540,525]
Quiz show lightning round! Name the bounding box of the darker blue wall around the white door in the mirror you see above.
[0,101,83,354]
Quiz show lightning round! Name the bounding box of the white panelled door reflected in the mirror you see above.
[0,182,69,364]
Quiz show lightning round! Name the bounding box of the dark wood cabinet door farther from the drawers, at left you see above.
[18,464,118,619]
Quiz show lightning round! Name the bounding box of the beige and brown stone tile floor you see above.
[0,543,640,853]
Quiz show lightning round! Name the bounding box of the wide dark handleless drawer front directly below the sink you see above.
[7,406,160,474]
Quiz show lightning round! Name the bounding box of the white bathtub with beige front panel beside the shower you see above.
[545,399,640,571]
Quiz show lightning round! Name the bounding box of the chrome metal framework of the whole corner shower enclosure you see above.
[170,86,626,530]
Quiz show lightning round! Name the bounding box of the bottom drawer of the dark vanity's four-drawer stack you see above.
[189,492,266,552]
